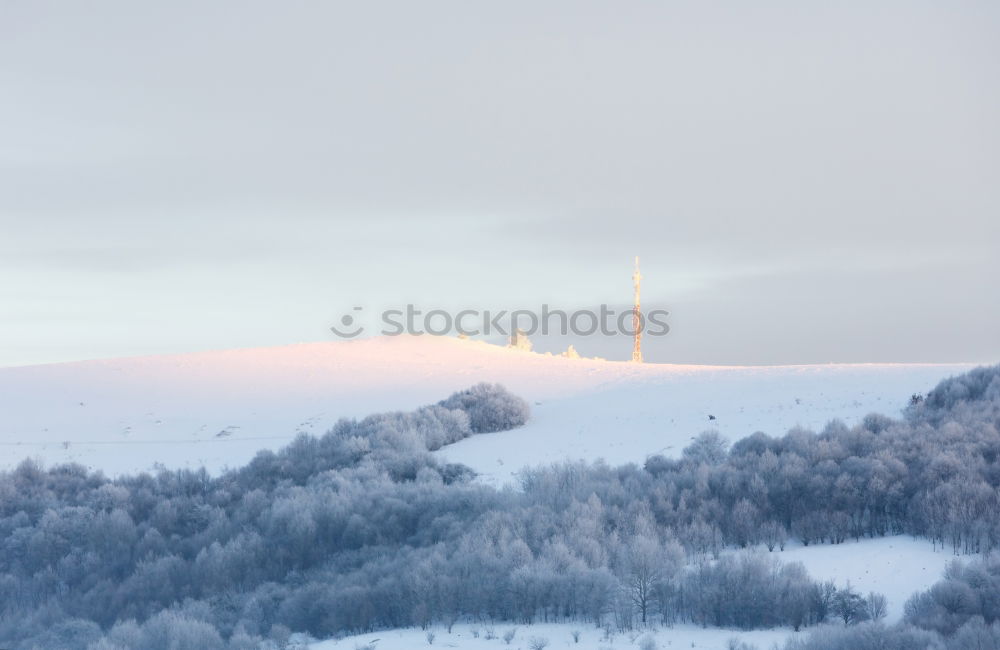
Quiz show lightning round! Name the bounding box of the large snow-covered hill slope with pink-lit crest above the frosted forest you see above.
[0,336,968,476]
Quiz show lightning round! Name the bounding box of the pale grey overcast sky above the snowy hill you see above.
[0,0,1000,365]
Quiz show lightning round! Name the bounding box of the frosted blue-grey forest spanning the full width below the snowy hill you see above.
[0,366,1000,650]
